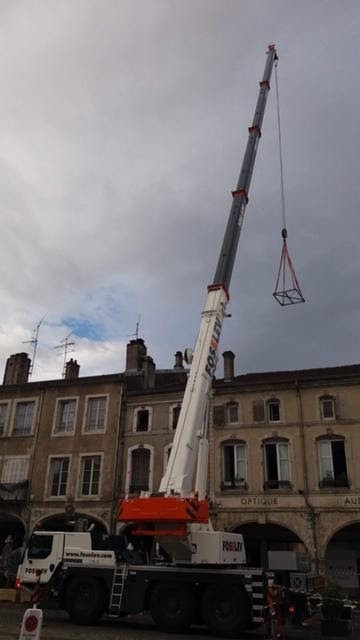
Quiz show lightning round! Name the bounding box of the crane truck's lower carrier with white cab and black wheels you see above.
[17,531,267,637]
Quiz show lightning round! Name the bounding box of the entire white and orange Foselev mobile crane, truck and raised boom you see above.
[17,45,288,637]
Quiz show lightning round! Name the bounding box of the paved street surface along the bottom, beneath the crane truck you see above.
[0,603,360,640]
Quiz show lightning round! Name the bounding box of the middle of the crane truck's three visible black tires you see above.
[150,582,195,633]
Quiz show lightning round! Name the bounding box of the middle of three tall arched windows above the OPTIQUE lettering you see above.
[264,442,290,489]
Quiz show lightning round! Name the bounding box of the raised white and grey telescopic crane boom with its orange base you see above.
[118,44,277,535]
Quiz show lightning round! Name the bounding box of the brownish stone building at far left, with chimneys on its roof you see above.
[0,354,123,542]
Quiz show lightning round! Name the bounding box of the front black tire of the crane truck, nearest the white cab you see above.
[65,577,106,624]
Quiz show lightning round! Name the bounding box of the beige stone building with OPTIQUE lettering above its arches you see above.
[210,354,360,588]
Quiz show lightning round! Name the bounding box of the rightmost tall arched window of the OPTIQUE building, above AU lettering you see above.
[318,438,349,487]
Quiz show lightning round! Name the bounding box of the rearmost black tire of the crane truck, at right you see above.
[201,584,251,638]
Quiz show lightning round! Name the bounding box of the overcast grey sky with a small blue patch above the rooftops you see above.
[0,0,360,380]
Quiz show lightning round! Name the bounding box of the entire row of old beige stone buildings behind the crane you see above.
[0,339,360,589]
